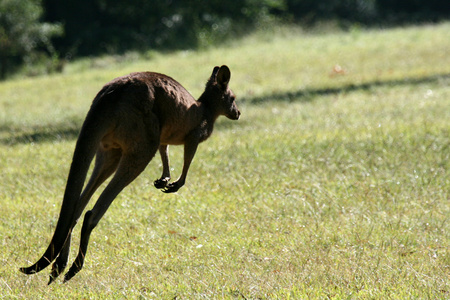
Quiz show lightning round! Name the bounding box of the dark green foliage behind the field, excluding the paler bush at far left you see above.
[43,0,450,56]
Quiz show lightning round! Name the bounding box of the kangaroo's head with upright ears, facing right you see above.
[205,66,241,120]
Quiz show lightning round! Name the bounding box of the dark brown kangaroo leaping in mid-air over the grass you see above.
[20,65,241,284]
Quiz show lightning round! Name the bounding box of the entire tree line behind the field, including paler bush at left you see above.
[0,0,450,79]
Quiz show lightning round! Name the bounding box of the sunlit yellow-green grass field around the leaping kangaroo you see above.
[0,23,450,299]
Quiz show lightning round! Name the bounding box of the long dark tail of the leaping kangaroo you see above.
[20,87,114,274]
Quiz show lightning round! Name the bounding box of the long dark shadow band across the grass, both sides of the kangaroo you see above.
[0,74,450,145]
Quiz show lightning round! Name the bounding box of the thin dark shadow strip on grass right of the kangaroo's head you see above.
[243,73,450,104]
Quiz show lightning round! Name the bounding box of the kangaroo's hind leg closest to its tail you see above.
[48,149,122,284]
